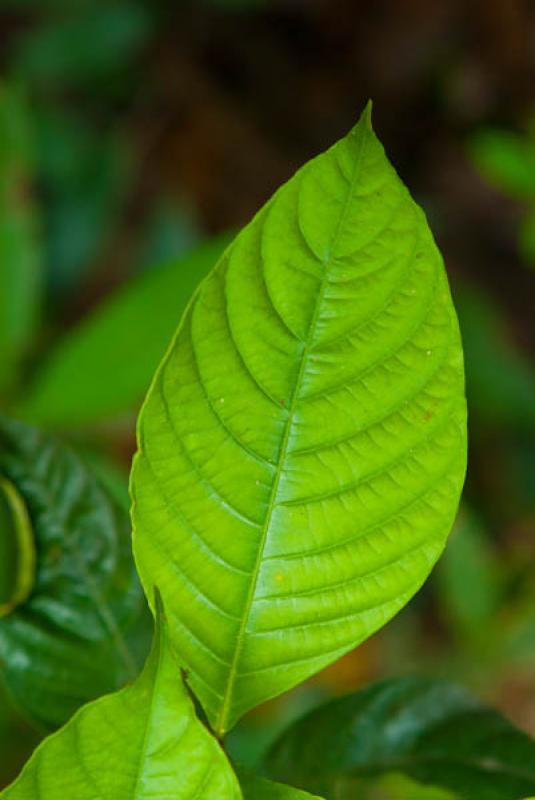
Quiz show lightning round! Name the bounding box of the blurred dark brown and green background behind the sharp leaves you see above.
[0,0,535,786]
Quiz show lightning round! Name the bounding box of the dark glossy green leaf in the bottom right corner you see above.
[268,678,535,800]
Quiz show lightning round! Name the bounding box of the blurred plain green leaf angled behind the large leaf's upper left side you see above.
[19,237,231,428]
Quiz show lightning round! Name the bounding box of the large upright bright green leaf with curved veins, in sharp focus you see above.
[132,103,466,732]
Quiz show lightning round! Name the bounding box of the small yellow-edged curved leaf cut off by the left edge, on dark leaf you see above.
[0,475,35,617]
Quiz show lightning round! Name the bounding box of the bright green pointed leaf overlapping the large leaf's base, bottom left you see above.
[0,600,241,800]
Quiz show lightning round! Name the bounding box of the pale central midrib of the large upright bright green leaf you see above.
[215,128,366,737]
